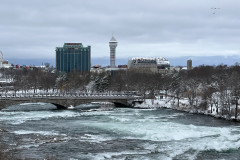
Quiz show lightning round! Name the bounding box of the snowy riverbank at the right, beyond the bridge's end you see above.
[134,97,240,122]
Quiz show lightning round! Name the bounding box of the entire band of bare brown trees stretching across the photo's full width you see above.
[1,64,240,118]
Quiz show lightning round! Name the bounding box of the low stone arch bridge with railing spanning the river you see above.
[0,93,143,109]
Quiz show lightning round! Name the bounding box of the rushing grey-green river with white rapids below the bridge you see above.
[0,104,240,160]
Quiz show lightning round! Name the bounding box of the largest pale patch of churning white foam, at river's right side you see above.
[78,108,240,159]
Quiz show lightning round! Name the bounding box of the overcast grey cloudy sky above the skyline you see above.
[0,0,240,62]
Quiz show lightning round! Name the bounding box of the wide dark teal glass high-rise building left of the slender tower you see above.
[56,43,91,73]
